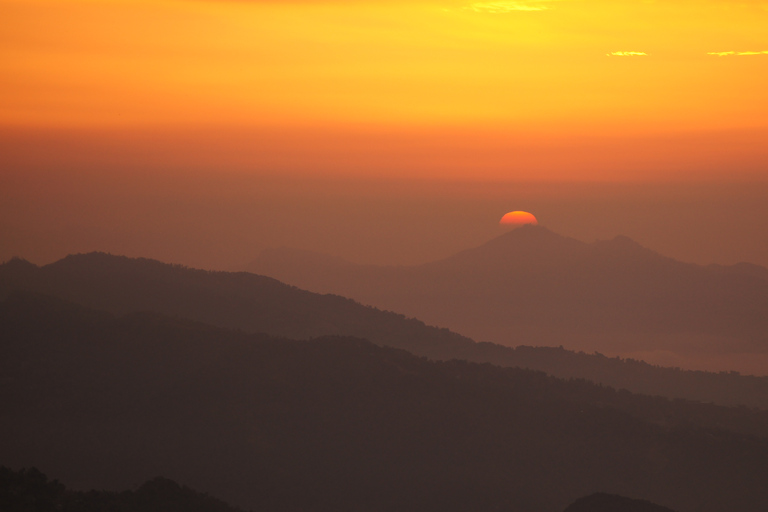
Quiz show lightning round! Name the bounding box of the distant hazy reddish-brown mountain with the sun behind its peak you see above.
[248,226,768,372]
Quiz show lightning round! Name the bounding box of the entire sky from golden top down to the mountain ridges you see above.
[0,0,768,268]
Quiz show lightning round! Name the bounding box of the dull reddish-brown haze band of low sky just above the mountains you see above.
[0,175,768,270]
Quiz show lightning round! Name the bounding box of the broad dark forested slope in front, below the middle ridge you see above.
[0,294,768,512]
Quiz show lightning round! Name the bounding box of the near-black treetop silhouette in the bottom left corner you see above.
[0,466,246,512]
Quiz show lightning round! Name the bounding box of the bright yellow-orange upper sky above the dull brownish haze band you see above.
[0,0,768,181]
